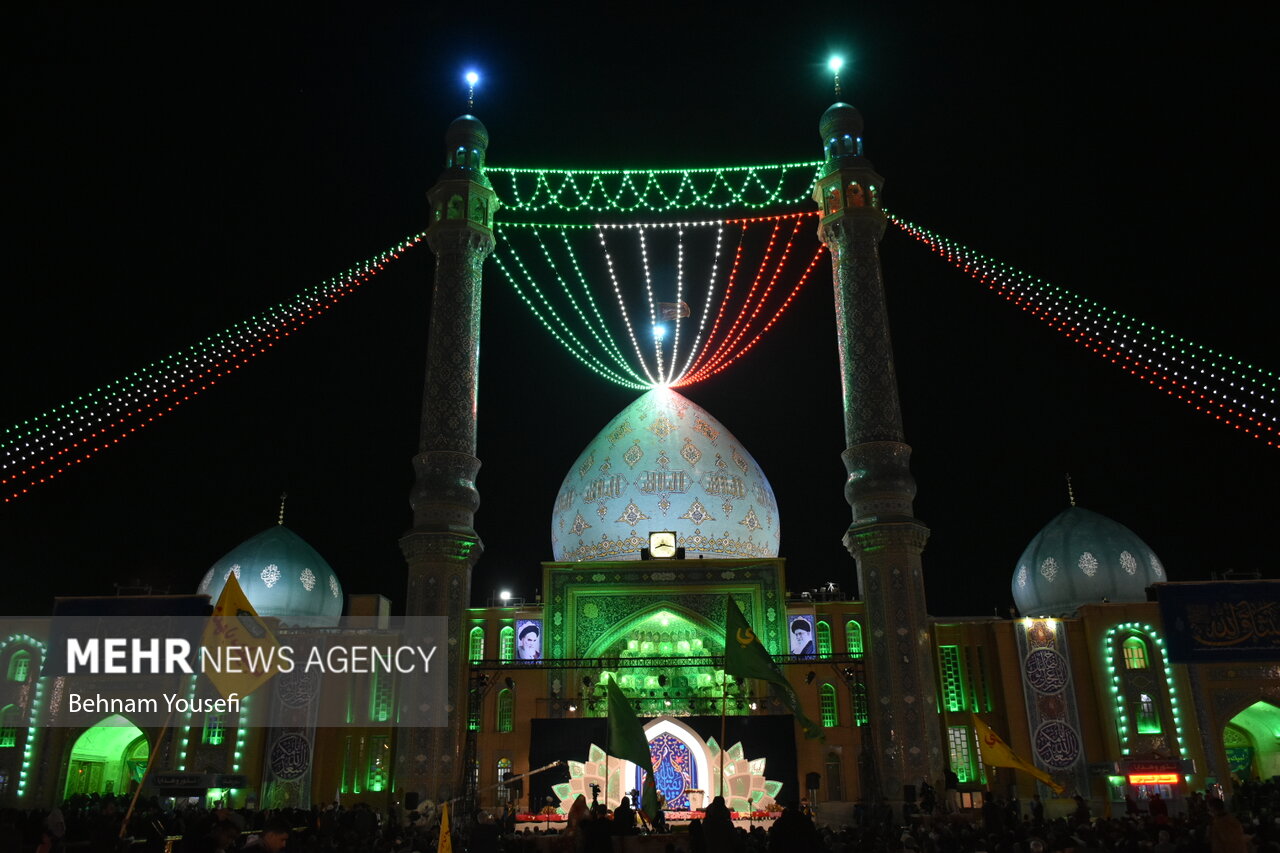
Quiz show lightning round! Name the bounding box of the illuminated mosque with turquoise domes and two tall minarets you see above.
[0,96,1280,820]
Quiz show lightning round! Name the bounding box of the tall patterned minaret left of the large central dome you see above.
[396,115,498,802]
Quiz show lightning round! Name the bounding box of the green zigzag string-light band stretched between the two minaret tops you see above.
[485,160,822,214]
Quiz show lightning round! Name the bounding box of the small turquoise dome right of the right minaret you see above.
[1012,506,1165,616]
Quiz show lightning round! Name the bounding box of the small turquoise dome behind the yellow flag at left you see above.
[196,524,343,628]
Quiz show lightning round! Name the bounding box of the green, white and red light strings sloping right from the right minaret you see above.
[888,214,1280,447]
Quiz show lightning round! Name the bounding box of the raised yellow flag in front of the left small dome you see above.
[202,573,280,699]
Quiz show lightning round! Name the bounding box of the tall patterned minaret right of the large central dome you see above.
[813,102,943,803]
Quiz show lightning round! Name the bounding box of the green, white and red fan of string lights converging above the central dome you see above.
[494,211,823,389]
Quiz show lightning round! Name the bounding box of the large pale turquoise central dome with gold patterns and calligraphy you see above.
[552,388,781,561]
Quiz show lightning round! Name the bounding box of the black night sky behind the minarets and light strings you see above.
[0,4,1280,615]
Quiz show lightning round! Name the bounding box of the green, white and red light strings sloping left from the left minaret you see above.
[0,232,425,503]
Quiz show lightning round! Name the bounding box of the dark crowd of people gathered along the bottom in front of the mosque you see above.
[0,780,1280,853]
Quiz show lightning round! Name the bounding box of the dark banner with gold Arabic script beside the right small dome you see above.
[1156,580,1280,663]
